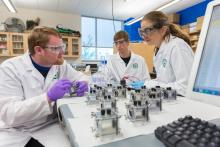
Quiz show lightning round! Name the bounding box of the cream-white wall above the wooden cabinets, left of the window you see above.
[0,6,81,31]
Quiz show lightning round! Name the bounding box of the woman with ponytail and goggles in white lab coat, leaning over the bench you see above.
[139,11,194,96]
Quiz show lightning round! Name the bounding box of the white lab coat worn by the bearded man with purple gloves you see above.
[0,53,89,147]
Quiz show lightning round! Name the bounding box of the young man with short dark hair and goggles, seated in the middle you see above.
[107,31,150,84]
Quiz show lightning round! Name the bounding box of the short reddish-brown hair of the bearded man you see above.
[28,26,61,55]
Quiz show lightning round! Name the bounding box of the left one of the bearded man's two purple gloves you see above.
[47,79,73,101]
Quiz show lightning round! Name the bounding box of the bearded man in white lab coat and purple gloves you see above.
[0,27,88,147]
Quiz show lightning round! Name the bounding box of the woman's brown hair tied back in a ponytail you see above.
[142,11,191,46]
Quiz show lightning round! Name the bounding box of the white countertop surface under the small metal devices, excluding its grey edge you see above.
[58,97,220,147]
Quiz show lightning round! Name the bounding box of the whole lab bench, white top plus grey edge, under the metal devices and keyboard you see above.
[57,97,220,147]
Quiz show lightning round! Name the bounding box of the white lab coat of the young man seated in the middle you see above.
[107,52,150,82]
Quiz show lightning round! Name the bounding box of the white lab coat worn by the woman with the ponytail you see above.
[146,35,194,96]
